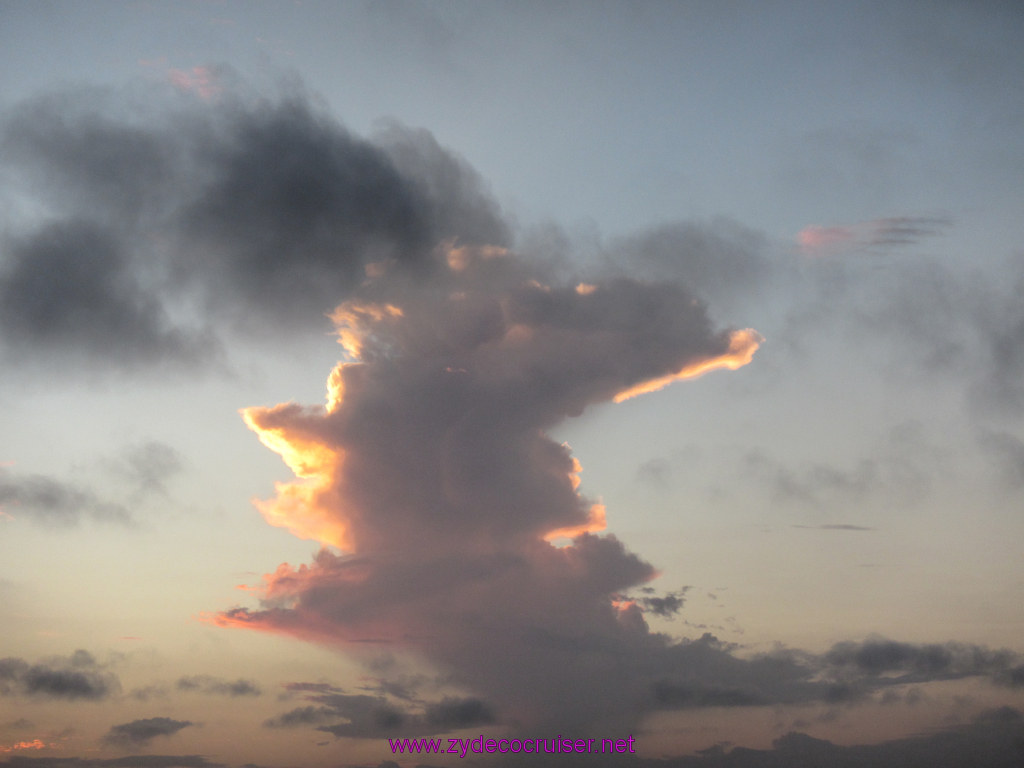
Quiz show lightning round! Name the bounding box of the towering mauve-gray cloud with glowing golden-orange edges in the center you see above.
[216,241,760,727]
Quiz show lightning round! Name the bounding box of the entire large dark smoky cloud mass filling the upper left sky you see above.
[0,79,511,369]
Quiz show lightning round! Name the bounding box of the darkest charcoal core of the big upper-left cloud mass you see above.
[172,98,432,323]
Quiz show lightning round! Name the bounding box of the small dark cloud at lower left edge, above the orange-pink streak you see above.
[0,650,121,701]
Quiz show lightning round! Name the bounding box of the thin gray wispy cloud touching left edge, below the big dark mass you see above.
[0,467,131,526]
